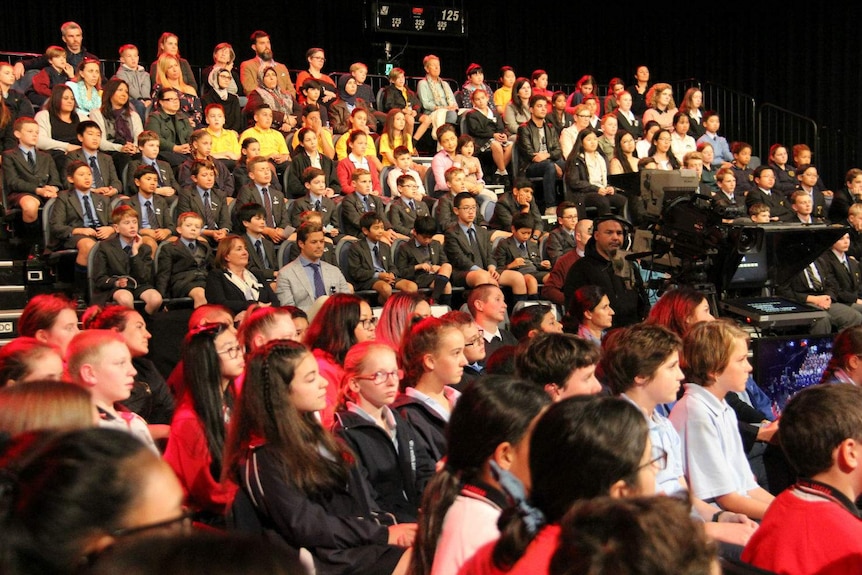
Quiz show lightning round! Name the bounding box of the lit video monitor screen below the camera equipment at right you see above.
[752,335,832,414]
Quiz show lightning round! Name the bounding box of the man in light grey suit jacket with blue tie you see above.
[275,222,353,312]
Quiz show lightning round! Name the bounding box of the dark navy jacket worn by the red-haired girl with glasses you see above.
[332,411,434,523]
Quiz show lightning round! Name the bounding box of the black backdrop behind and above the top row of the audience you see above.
[6,0,862,176]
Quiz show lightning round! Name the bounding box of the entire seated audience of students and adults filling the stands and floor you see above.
[0,18,862,575]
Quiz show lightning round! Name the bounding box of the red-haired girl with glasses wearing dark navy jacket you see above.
[333,341,434,522]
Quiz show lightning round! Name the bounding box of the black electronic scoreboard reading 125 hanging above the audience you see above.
[372,2,467,37]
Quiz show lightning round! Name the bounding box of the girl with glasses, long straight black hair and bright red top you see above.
[165,323,245,525]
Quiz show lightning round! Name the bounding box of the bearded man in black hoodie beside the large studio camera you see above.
[563,216,649,328]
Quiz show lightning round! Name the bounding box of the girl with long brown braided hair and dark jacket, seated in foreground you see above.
[225,340,416,575]
